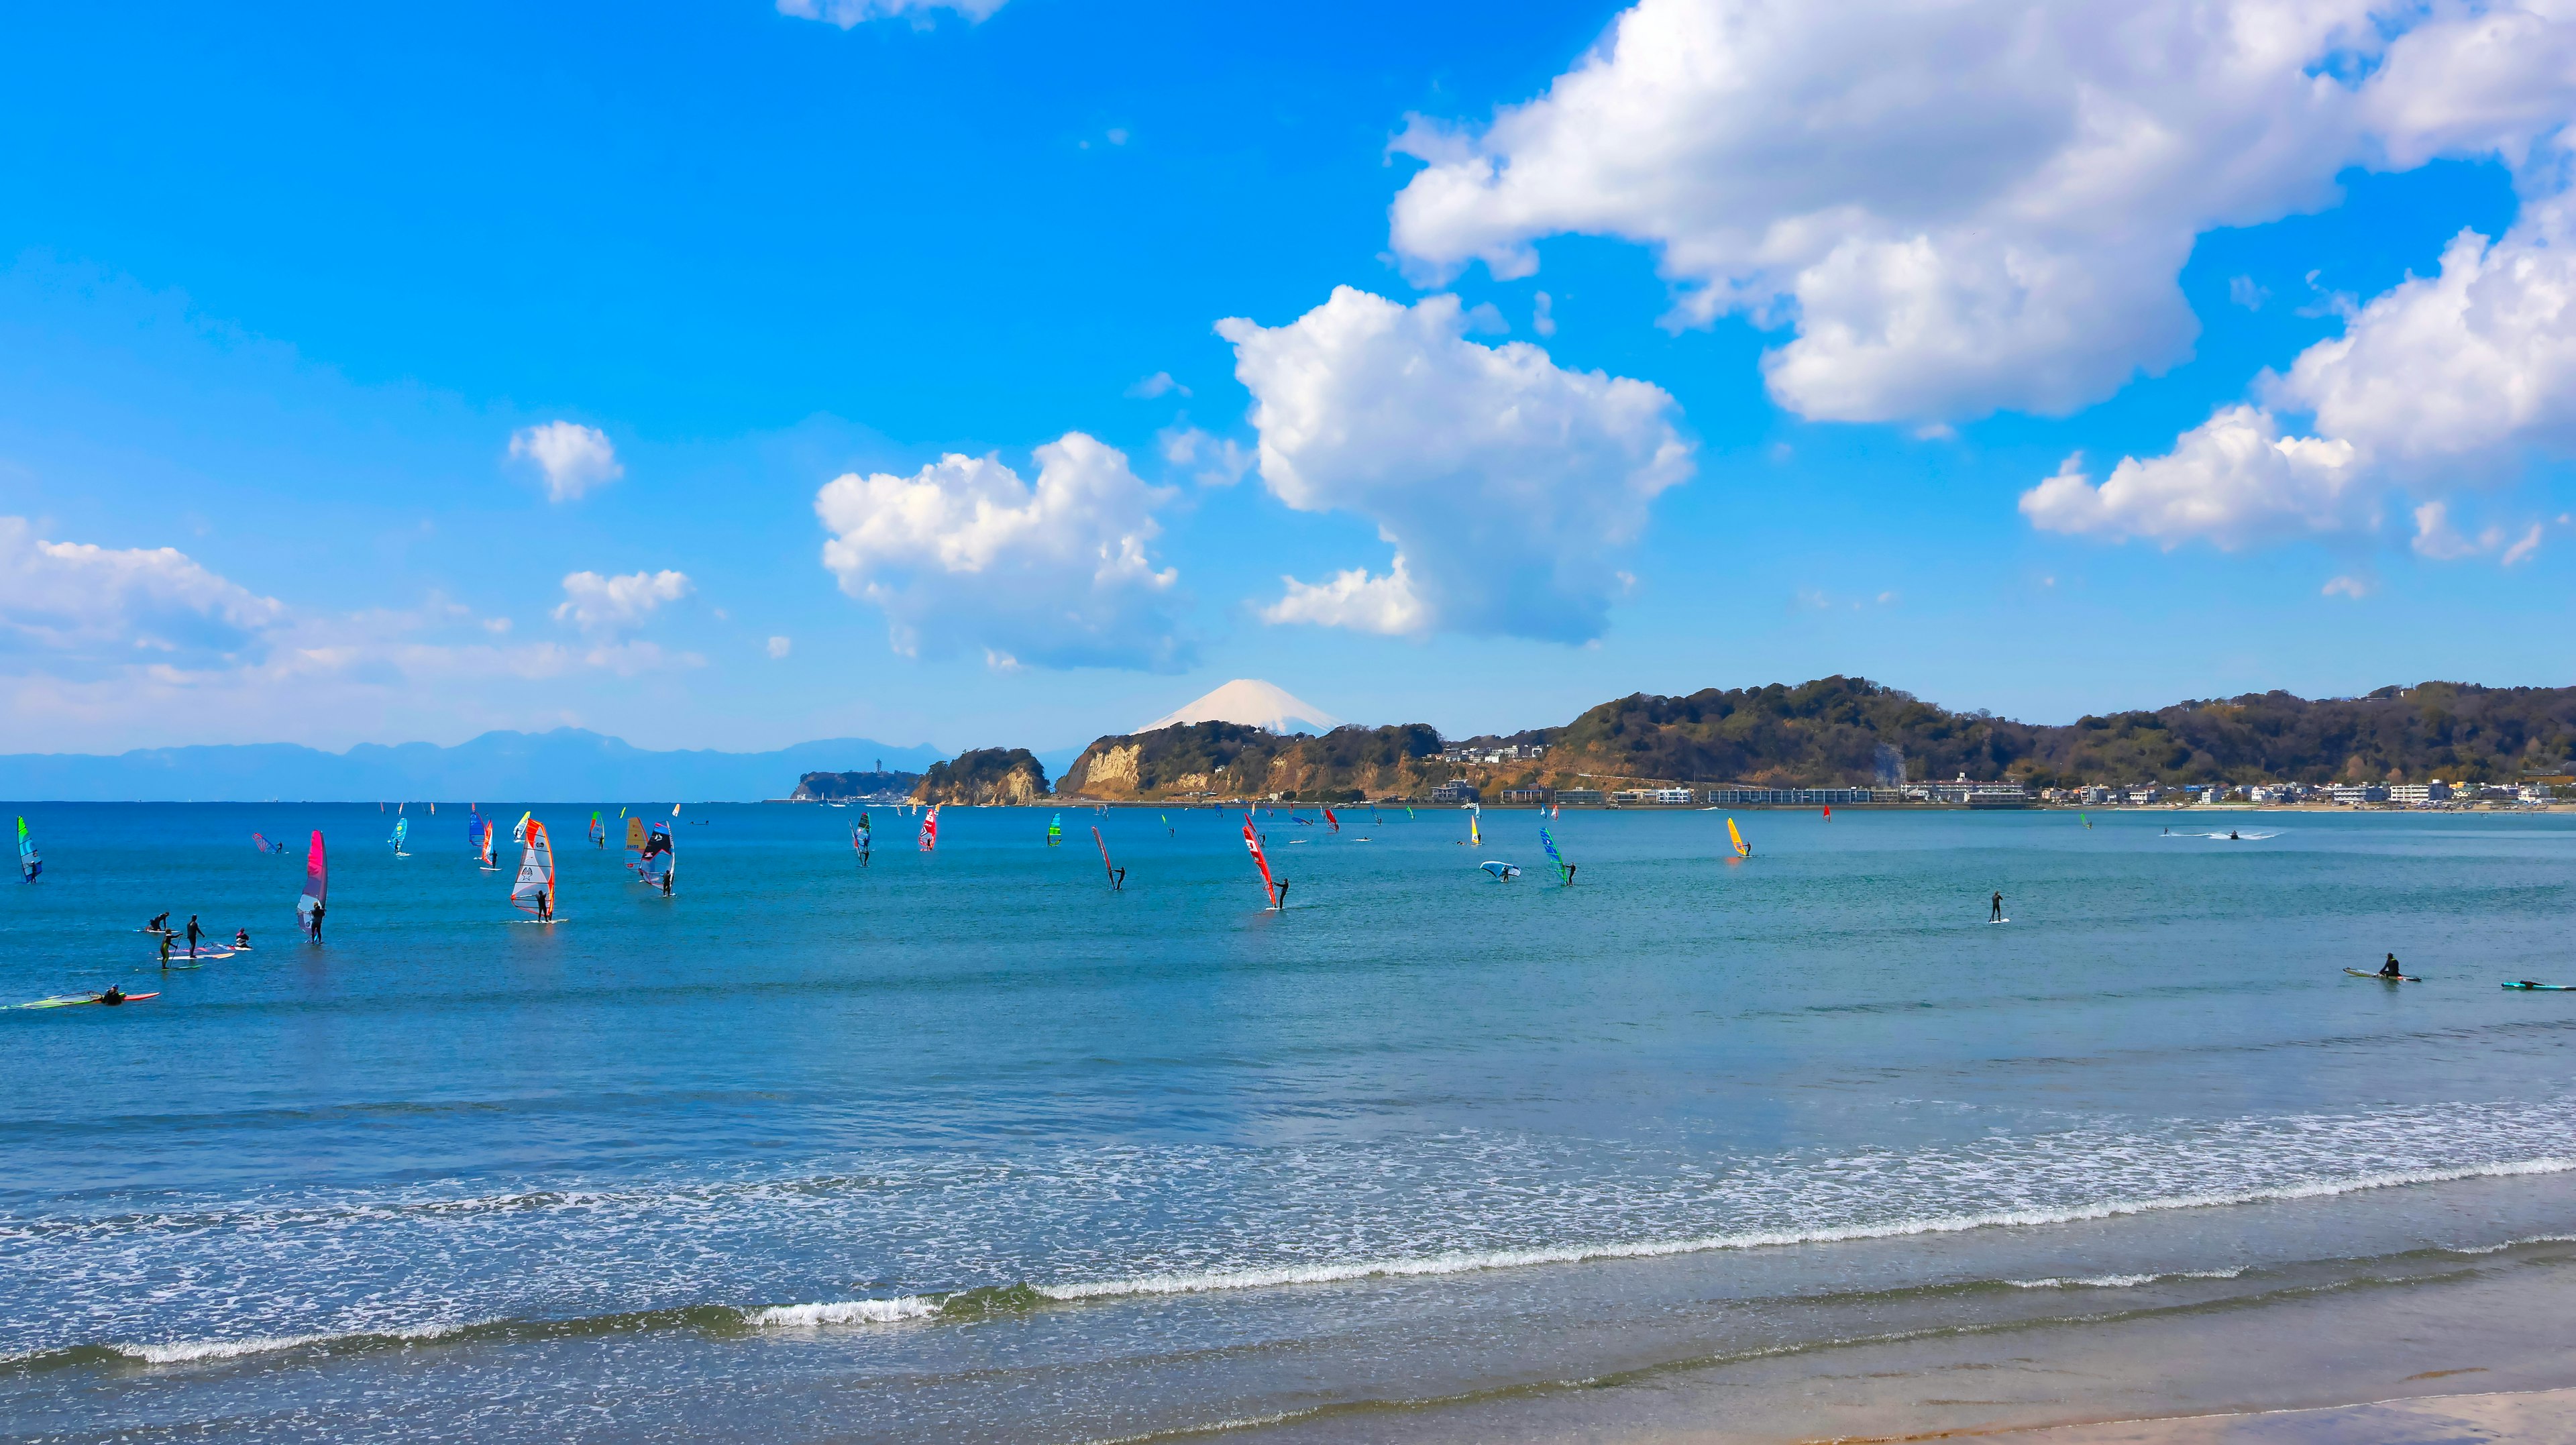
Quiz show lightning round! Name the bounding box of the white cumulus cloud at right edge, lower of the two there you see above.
[2022,206,2576,553]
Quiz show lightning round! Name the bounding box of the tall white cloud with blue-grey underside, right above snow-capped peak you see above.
[1216,286,1693,641]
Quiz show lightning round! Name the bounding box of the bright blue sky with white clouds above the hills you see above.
[0,0,2576,752]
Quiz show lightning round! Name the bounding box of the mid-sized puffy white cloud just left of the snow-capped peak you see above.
[814,433,1187,670]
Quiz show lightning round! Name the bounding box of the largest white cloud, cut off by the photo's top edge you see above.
[1391,0,2576,420]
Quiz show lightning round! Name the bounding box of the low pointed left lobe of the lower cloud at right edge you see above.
[2022,407,2375,551]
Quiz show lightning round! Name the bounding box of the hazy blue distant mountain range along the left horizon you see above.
[0,727,948,804]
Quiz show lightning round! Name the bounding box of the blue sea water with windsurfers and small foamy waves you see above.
[0,804,2576,1442]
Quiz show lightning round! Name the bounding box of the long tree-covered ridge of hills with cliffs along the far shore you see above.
[1035,675,2576,801]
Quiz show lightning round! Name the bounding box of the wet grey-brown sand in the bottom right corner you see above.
[1229,1226,2576,1445]
